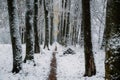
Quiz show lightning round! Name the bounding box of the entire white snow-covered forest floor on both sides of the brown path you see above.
[0,43,105,80]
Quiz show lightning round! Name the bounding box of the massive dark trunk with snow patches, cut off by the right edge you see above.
[104,0,120,80]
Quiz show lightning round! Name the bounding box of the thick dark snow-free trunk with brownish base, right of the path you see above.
[82,0,96,77]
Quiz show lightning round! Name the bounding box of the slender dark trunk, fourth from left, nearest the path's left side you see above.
[44,0,49,50]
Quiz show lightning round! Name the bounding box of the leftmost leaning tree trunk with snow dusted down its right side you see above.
[7,0,22,73]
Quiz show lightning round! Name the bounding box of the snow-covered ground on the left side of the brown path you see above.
[0,45,52,80]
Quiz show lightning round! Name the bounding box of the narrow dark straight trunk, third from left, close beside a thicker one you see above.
[34,0,40,53]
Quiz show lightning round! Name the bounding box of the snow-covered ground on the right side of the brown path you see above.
[57,43,105,80]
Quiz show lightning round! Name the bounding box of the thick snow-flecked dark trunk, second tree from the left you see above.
[24,0,34,62]
